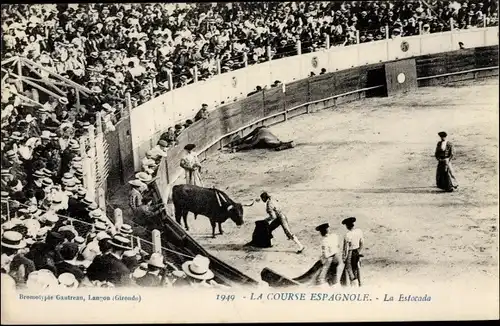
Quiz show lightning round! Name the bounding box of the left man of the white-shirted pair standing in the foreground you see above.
[316,223,340,285]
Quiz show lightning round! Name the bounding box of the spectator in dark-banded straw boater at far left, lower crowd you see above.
[1,231,35,284]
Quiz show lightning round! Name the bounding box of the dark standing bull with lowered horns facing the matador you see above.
[172,184,254,238]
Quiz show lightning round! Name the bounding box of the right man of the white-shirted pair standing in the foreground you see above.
[340,217,364,286]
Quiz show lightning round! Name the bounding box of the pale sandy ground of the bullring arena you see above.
[175,79,498,288]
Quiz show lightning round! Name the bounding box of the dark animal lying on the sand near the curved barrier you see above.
[229,126,295,152]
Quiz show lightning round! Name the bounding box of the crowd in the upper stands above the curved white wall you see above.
[2,0,497,106]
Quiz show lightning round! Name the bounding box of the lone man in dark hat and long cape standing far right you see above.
[434,131,458,192]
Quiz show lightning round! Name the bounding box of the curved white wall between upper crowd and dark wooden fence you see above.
[131,27,498,169]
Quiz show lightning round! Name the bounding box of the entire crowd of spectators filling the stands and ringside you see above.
[1,0,498,286]
